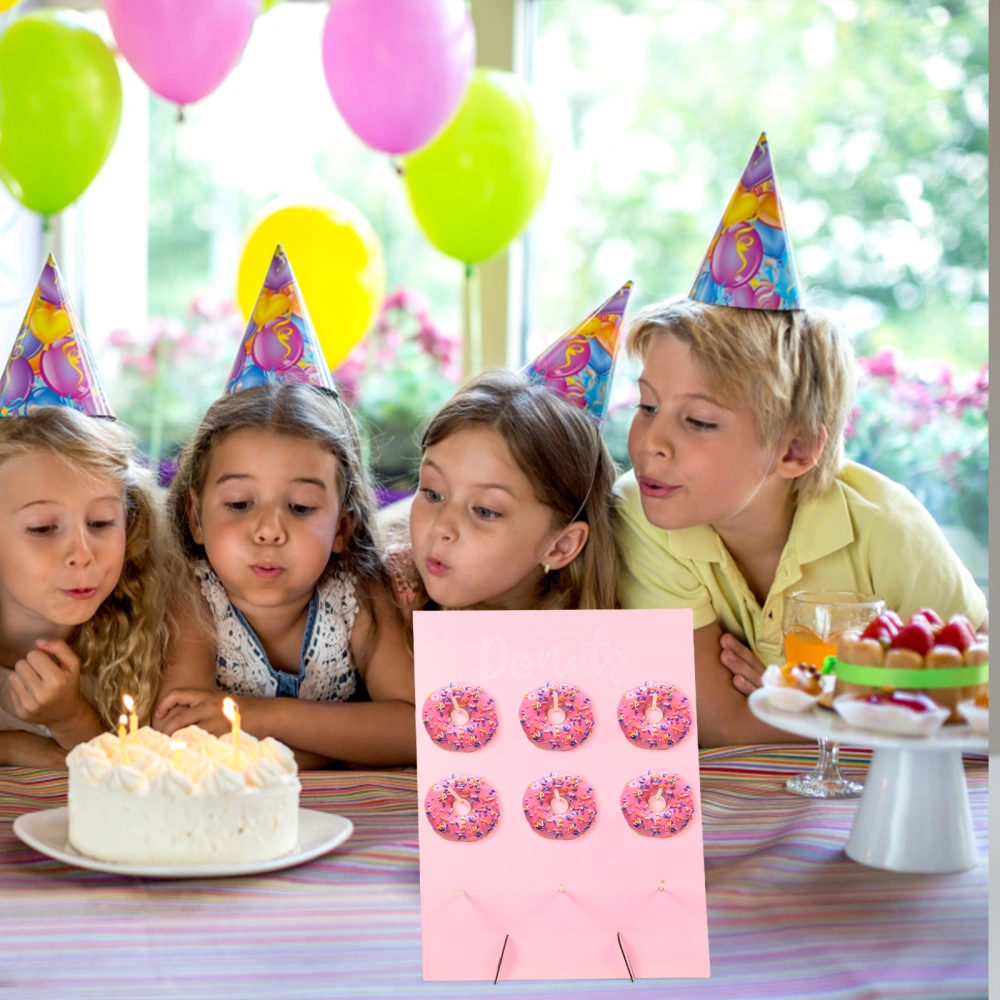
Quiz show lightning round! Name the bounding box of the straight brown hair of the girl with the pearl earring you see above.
[420,368,618,608]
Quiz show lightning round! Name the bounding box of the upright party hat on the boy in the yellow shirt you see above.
[688,132,804,309]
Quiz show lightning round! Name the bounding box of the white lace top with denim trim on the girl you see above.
[194,560,358,701]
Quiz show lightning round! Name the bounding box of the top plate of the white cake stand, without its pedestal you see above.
[749,688,989,753]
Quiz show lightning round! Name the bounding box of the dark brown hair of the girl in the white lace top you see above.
[169,382,391,598]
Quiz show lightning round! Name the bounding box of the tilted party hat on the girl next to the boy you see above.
[522,281,632,423]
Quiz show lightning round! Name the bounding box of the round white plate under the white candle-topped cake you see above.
[14,807,354,878]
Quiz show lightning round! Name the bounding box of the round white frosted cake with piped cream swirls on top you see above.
[66,726,301,865]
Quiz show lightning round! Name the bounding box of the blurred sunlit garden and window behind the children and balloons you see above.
[0,0,989,584]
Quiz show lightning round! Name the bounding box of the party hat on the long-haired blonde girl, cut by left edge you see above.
[0,254,115,420]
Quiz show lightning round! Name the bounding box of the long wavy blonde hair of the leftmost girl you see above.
[0,406,181,728]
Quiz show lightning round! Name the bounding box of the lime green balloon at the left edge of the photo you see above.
[0,10,122,215]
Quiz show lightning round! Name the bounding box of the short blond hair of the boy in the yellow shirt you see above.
[625,298,855,498]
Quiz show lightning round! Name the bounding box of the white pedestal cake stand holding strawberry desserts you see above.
[749,689,989,874]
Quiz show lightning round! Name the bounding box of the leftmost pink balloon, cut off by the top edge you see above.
[104,0,260,104]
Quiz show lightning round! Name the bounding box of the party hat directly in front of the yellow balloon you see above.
[224,244,337,395]
